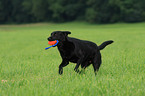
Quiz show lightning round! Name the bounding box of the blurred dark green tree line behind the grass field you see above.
[0,0,145,24]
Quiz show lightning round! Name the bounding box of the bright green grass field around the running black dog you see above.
[0,22,145,96]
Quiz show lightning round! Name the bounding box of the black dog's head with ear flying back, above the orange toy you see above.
[48,31,71,41]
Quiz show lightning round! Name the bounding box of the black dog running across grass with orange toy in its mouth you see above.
[48,31,113,74]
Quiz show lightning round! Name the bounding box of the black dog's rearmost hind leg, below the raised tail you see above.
[92,53,102,75]
